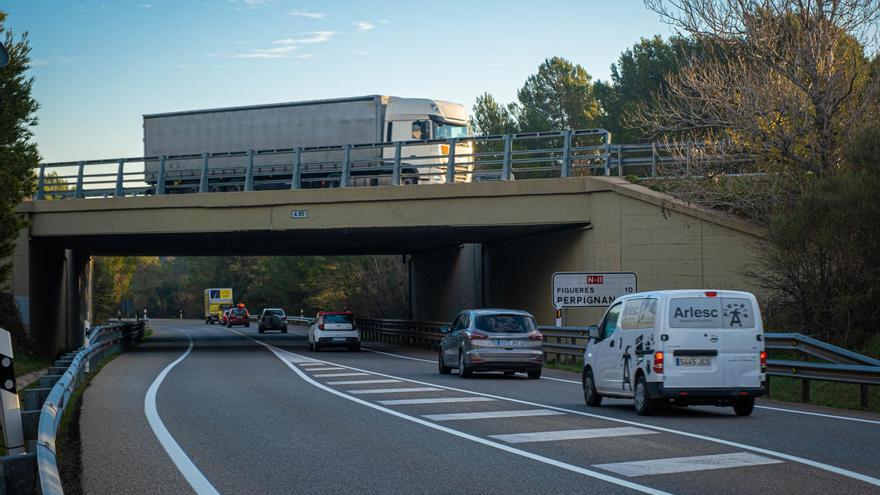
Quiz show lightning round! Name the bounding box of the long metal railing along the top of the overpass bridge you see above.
[34,129,754,200]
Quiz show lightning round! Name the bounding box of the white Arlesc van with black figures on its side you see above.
[582,290,767,416]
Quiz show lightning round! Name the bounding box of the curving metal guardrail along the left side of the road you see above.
[36,321,145,495]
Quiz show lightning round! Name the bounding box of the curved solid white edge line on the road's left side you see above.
[144,329,219,495]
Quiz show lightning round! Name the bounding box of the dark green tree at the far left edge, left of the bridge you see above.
[0,12,40,287]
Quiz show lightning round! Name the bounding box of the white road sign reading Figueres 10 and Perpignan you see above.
[553,272,638,309]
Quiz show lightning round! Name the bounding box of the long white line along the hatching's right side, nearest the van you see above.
[288,356,880,486]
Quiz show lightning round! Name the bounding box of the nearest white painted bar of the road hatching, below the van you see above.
[593,452,782,477]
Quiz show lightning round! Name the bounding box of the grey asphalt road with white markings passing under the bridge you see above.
[80,320,880,495]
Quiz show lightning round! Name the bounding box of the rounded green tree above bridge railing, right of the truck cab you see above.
[516,57,600,131]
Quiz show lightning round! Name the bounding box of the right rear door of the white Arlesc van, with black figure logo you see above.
[721,293,763,388]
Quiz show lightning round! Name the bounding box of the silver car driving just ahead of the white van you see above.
[437,309,544,379]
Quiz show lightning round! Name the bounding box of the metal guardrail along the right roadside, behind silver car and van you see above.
[357,318,880,407]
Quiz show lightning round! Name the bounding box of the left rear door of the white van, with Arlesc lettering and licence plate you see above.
[661,293,726,388]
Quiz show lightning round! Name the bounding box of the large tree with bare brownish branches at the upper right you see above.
[638,0,880,174]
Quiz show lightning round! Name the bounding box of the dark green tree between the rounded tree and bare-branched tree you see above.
[593,35,700,143]
